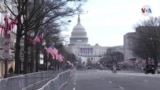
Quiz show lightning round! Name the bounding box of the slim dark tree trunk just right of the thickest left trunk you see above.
[24,34,28,74]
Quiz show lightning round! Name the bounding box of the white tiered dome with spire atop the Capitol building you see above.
[70,15,88,45]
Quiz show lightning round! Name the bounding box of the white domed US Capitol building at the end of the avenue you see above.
[66,15,107,64]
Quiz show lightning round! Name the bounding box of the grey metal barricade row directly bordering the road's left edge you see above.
[38,70,74,90]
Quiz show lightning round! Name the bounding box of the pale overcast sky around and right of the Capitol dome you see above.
[62,0,160,46]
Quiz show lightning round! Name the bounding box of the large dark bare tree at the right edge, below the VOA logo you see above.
[130,17,160,66]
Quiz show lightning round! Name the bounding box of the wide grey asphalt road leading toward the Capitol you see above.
[62,70,160,90]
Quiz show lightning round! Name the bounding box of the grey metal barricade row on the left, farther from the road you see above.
[0,71,59,90]
